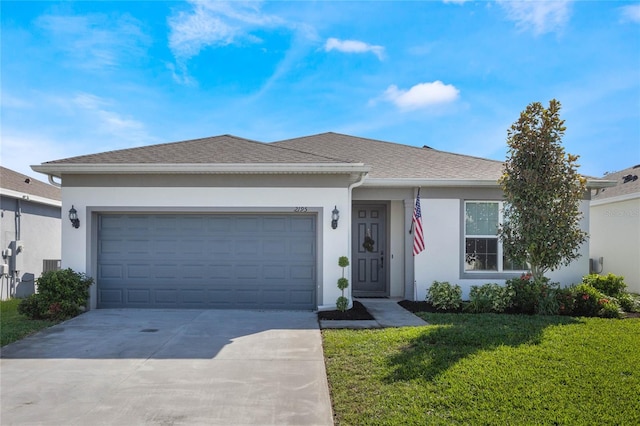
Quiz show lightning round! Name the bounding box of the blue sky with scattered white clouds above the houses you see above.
[0,1,640,179]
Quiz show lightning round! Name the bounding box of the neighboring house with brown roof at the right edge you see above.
[589,164,640,293]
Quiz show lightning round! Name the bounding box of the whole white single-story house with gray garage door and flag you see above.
[32,133,606,310]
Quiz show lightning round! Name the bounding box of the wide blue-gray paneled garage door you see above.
[97,214,316,309]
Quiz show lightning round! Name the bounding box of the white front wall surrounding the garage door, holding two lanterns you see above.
[62,187,351,309]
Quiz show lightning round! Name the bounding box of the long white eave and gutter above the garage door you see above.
[31,163,371,178]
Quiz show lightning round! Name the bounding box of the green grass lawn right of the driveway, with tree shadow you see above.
[322,314,640,425]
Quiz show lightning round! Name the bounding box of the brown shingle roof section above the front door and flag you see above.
[271,132,503,181]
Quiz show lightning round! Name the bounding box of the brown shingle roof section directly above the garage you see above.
[43,135,352,164]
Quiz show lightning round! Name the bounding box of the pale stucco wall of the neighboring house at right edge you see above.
[590,196,640,293]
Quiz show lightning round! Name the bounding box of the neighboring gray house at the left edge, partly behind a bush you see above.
[0,167,62,300]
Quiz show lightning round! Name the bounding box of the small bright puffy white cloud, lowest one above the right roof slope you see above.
[383,80,460,110]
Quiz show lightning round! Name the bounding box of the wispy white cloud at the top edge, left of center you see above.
[169,1,283,61]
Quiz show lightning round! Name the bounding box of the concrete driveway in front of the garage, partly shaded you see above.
[0,310,333,426]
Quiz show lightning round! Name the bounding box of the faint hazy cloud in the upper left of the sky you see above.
[37,14,150,70]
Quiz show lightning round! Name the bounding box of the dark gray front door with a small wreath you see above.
[351,204,389,297]
